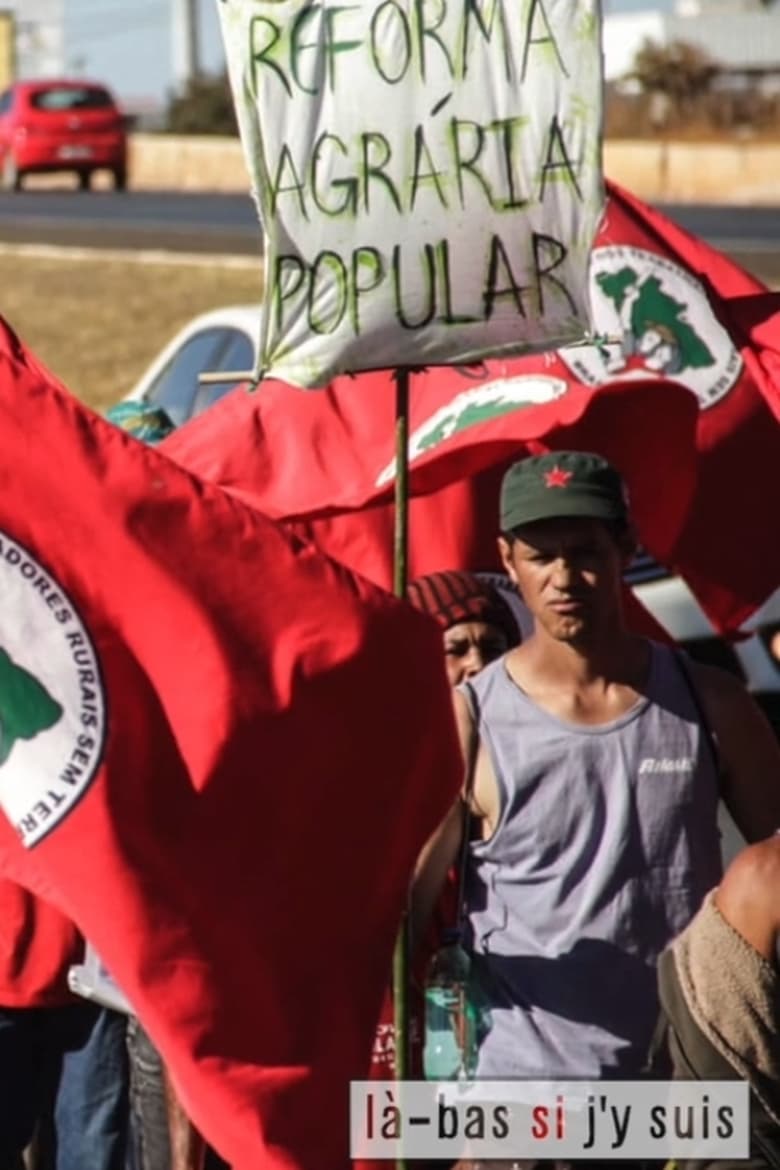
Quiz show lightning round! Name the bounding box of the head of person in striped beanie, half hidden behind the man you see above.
[407,569,520,687]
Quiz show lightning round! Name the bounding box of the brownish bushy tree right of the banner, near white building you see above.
[630,40,720,125]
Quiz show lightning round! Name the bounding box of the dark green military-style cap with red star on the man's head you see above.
[501,450,628,532]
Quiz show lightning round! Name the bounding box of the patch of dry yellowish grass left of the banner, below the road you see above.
[0,248,262,408]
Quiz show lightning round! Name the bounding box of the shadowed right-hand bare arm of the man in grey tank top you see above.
[690,663,780,842]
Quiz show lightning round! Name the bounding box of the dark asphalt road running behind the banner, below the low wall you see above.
[0,190,780,281]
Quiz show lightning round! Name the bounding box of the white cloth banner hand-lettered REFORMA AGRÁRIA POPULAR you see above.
[219,0,603,386]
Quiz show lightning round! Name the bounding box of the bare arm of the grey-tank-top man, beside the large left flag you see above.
[409,691,477,948]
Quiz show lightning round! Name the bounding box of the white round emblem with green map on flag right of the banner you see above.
[558,245,743,410]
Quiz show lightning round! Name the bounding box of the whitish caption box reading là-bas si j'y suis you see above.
[350,1081,750,1161]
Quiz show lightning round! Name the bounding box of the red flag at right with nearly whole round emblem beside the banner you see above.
[589,185,780,632]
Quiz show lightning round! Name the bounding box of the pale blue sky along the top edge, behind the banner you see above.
[62,0,672,105]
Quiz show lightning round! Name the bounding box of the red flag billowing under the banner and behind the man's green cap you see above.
[160,365,696,572]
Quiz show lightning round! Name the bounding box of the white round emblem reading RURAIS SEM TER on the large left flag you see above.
[0,532,105,846]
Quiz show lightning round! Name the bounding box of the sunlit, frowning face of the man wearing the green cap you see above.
[498,517,630,645]
